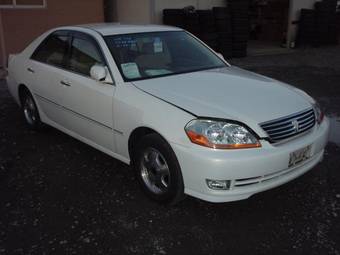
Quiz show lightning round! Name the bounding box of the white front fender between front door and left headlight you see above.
[113,83,195,158]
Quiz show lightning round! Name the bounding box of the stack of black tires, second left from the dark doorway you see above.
[213,7,232,58]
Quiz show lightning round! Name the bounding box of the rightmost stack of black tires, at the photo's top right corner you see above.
[315,0,337,45]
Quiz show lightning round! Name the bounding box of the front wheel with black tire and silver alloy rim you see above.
[134,134,184,205]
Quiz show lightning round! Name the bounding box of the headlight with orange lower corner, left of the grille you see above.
[185,119,261,149]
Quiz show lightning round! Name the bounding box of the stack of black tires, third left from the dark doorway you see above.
[197,10,218,50]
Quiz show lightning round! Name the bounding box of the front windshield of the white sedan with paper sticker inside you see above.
[105,31,226,81]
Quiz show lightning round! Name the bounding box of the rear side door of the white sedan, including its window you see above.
[29,31,71,124]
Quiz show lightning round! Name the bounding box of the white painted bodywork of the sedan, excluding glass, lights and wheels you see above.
[7,24,329,202]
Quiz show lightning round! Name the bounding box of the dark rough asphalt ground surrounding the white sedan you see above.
[0,47,340,255]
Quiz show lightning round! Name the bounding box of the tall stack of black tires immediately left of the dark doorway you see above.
[228,0,249,57]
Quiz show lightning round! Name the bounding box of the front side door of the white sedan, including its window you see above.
[62,32,115,151]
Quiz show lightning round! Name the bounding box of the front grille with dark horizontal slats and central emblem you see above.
[260,109,315,143]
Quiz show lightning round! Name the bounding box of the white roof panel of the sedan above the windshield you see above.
[77,23,182,36]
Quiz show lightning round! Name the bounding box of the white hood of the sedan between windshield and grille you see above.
[133,67,311,130]
